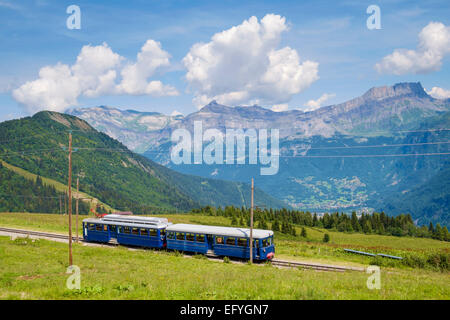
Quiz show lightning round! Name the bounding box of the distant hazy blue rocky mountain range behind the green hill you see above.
[71,83,450,226]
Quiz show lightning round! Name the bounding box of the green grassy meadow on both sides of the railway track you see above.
[0,213,450,299]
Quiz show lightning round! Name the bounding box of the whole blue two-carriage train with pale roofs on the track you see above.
[83,214,275,261]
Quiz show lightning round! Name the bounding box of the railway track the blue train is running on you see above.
[0,227,365,272]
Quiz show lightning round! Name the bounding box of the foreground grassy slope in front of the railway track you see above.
[0,237,450,299]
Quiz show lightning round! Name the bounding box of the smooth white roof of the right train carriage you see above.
[166,223,273,239]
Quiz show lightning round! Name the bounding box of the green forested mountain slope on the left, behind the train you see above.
[0,111,284,213]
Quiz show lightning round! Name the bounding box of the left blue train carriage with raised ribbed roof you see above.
[83,214,171,248]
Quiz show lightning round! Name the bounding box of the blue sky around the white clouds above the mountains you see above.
[0,0,450,121]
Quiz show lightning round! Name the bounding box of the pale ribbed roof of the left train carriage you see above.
[83,214,172,229]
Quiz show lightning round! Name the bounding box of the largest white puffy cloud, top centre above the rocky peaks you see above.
[183,14,319,107]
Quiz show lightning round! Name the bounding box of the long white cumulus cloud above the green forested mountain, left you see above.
[12,40,177,113]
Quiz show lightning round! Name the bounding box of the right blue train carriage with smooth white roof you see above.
[166,224,275,260]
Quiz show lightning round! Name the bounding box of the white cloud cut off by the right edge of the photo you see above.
[375,22,450,75]
